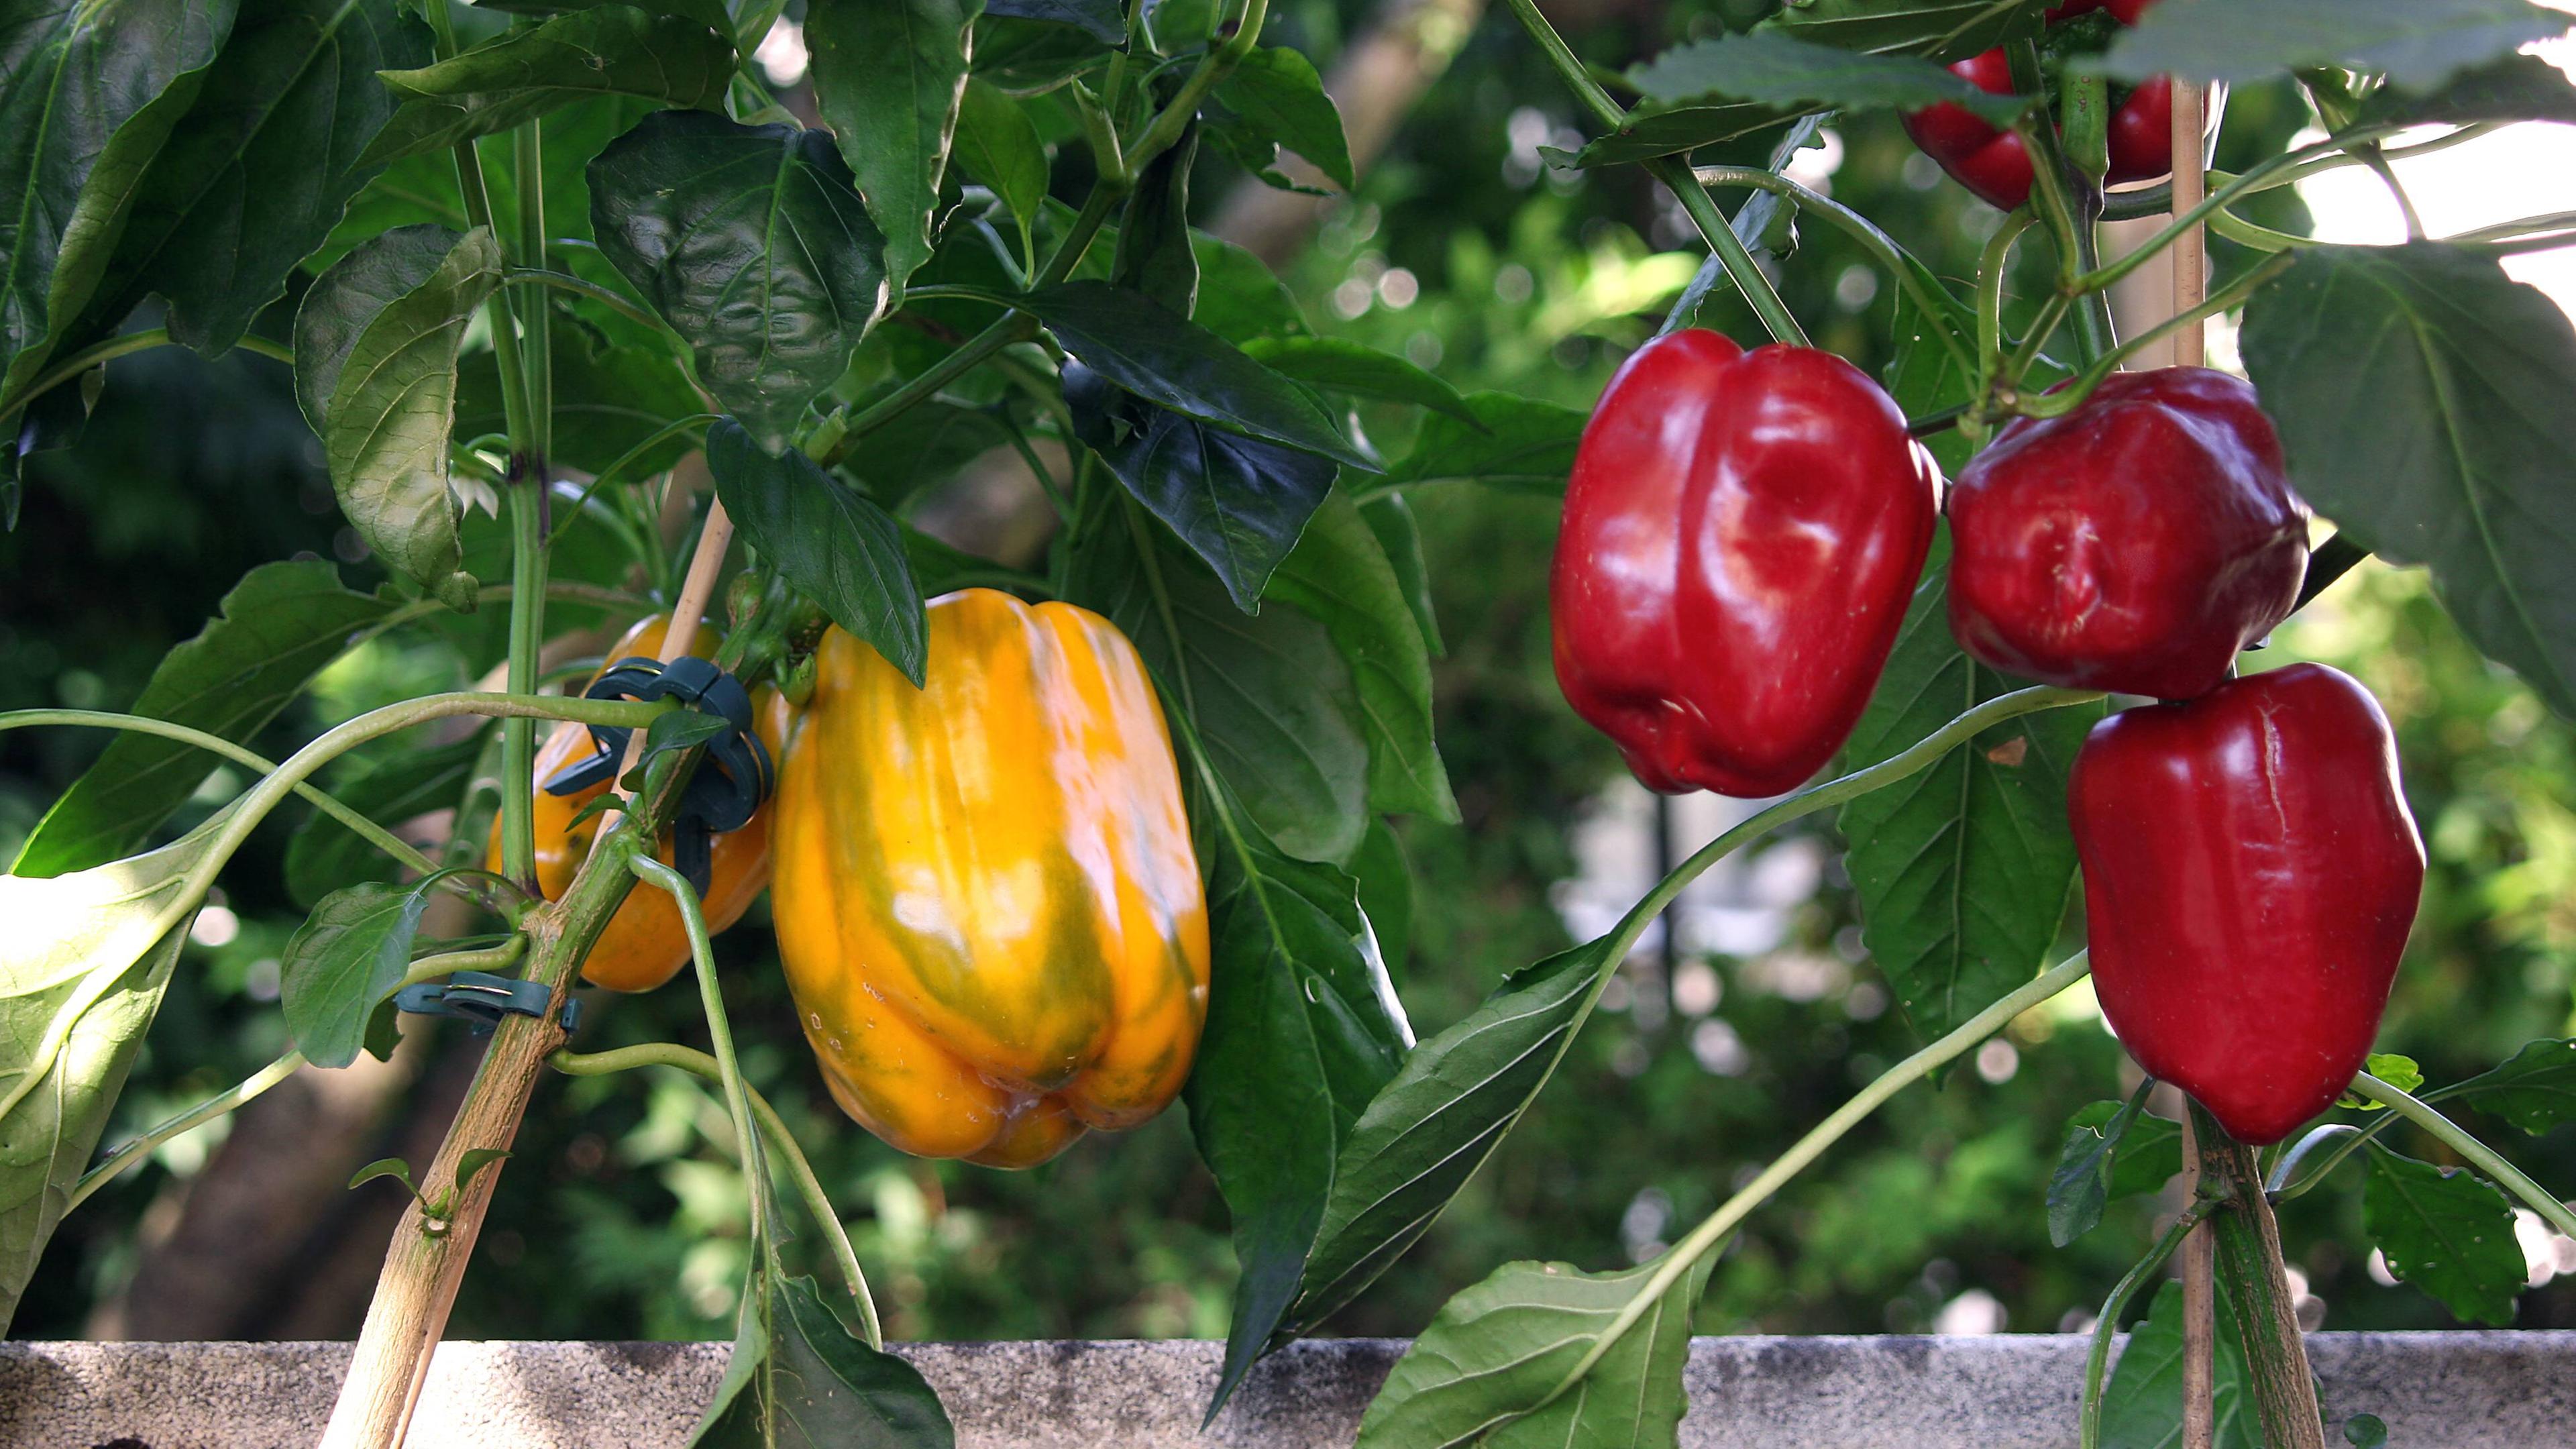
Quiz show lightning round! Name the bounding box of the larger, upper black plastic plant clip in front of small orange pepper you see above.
[546,657,778,895]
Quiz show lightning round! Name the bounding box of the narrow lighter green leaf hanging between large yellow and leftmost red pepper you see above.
[1270,492,1458,825]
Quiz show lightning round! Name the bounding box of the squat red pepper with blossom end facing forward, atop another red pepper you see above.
[1950,366,2308,699]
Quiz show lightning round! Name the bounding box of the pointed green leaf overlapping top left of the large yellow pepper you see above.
[706,418,930,686]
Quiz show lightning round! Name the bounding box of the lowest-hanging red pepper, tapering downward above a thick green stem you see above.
[2066,665,2424,1147]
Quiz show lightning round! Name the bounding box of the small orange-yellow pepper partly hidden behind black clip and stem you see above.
[484,614,791,990]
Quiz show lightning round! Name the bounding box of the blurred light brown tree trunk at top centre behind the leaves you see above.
[1208,0,1484,268]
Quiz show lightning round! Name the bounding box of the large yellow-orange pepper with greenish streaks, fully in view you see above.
[770,588,1208,1168]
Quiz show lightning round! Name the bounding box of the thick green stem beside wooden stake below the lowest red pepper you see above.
[2192,1101,2326,1449]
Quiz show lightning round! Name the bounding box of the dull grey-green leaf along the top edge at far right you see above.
[2102,0,2568,91]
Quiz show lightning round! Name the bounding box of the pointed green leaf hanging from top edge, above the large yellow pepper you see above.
[806,0,981,291]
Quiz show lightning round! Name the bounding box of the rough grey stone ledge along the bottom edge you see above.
[0,1330,2576,1449]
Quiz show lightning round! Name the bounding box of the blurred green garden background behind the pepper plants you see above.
[0,0,2576,1338]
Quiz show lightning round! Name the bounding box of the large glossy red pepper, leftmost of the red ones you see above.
[1548,330,1940,797]
